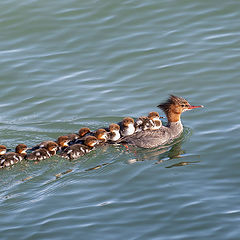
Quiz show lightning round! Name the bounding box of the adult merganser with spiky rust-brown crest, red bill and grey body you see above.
[120,95,203,148]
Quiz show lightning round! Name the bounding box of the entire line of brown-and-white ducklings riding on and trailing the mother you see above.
[0,112,162,168]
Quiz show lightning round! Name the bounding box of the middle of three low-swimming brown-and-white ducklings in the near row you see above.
[26,141,58,161]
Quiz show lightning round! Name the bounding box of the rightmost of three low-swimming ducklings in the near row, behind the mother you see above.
[60,136,98,160]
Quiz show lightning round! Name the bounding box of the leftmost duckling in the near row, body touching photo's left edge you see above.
[0,144,27,168]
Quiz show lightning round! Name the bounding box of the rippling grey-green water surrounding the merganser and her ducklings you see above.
[0,0,240,240]
